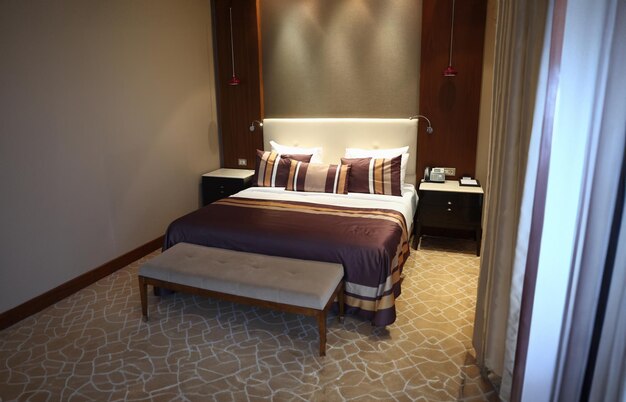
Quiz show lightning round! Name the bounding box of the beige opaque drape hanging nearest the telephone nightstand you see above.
[473,0,549,400]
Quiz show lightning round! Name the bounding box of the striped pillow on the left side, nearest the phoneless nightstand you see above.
[253,149,311,187]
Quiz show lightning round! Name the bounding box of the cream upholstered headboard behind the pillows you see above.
[263,118,417,184]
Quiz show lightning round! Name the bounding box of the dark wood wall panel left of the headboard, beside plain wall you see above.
[212,0,263,169]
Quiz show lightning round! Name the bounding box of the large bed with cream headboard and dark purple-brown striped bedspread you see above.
[163,119,417,326]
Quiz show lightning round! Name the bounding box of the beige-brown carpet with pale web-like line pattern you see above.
[0,237,498,402]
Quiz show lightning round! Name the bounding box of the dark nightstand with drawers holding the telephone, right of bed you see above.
[415,180,483,256]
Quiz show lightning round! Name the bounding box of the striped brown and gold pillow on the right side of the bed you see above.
[341,155,402,196]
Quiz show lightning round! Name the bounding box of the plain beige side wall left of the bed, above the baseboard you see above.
[0,0,219,312]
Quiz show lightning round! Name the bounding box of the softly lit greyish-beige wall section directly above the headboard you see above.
[260,0,422,118]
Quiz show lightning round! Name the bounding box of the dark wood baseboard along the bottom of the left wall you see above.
[0,236,163,330]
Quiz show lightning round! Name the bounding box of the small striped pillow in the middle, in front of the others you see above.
[286,160,350,194]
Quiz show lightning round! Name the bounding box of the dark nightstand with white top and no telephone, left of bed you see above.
[202,169,254,206]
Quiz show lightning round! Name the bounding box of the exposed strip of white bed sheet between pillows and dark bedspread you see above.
[233,183,417,229]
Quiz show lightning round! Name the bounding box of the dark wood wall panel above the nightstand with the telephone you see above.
[417,0,487,178]
